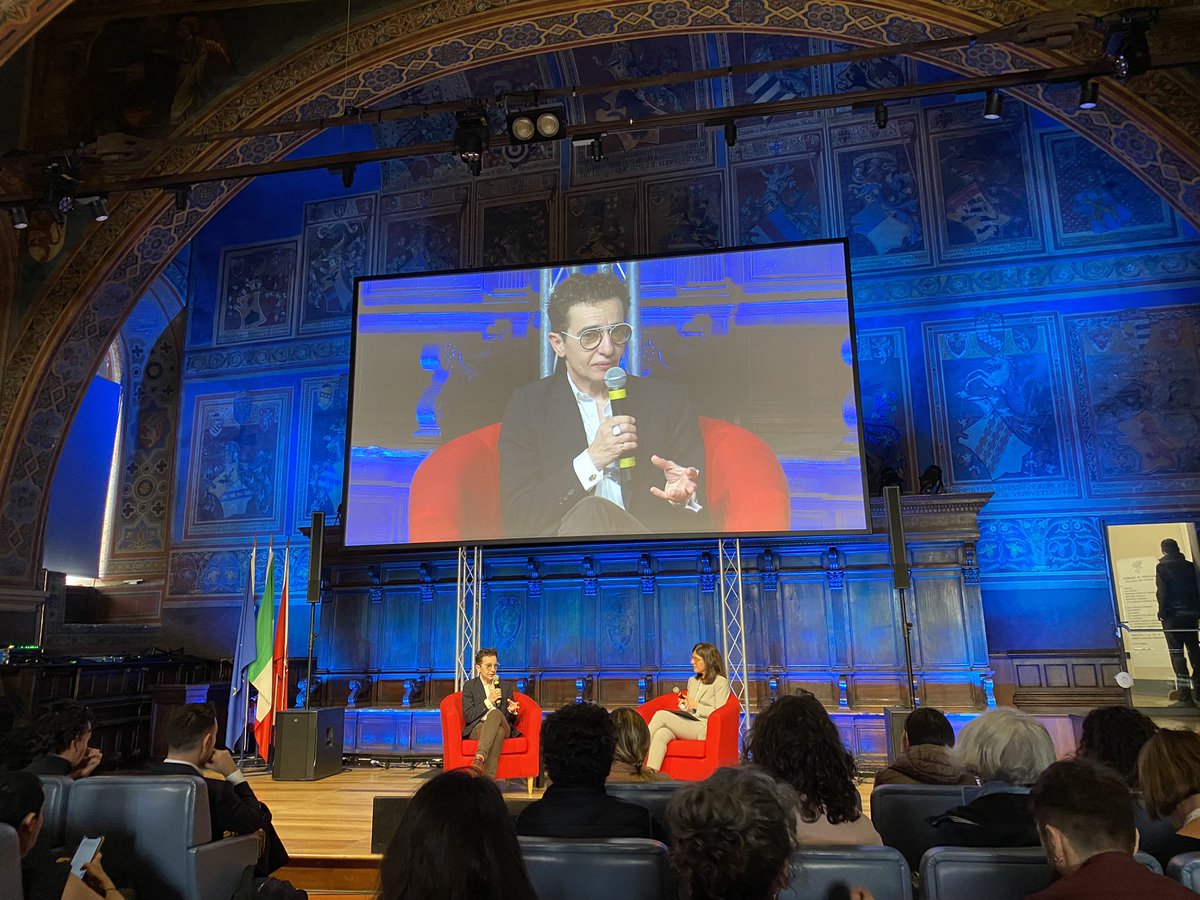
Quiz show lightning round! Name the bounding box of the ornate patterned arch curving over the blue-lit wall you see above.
[0,0,1200,583]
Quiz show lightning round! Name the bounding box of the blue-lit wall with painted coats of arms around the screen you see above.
[157,35,1200,681]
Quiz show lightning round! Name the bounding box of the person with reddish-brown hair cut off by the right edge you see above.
[1138,728,1200,869]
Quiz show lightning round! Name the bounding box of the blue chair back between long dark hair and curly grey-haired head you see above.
[518,836,674,900]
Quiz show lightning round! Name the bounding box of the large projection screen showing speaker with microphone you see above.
[344,241,870,547]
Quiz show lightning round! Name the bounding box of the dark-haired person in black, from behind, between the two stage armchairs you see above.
[517,703,665,840]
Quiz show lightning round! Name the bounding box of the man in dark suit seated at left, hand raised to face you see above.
[144,703,288,876]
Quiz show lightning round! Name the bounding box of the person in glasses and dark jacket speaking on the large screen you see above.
[499,272,708,538]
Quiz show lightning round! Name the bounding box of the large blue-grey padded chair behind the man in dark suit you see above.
[66,775,258,900]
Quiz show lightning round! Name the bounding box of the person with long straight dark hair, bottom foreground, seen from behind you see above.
[378,770,538,900]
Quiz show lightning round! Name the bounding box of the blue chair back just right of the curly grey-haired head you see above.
[779,847,912,900]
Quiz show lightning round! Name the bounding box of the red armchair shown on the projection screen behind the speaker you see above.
[408,415,792,544]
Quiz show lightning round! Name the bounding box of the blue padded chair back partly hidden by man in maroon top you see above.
[920,847,1163,900]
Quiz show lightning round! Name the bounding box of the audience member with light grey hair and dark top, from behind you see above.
[930,708,1055,847]
